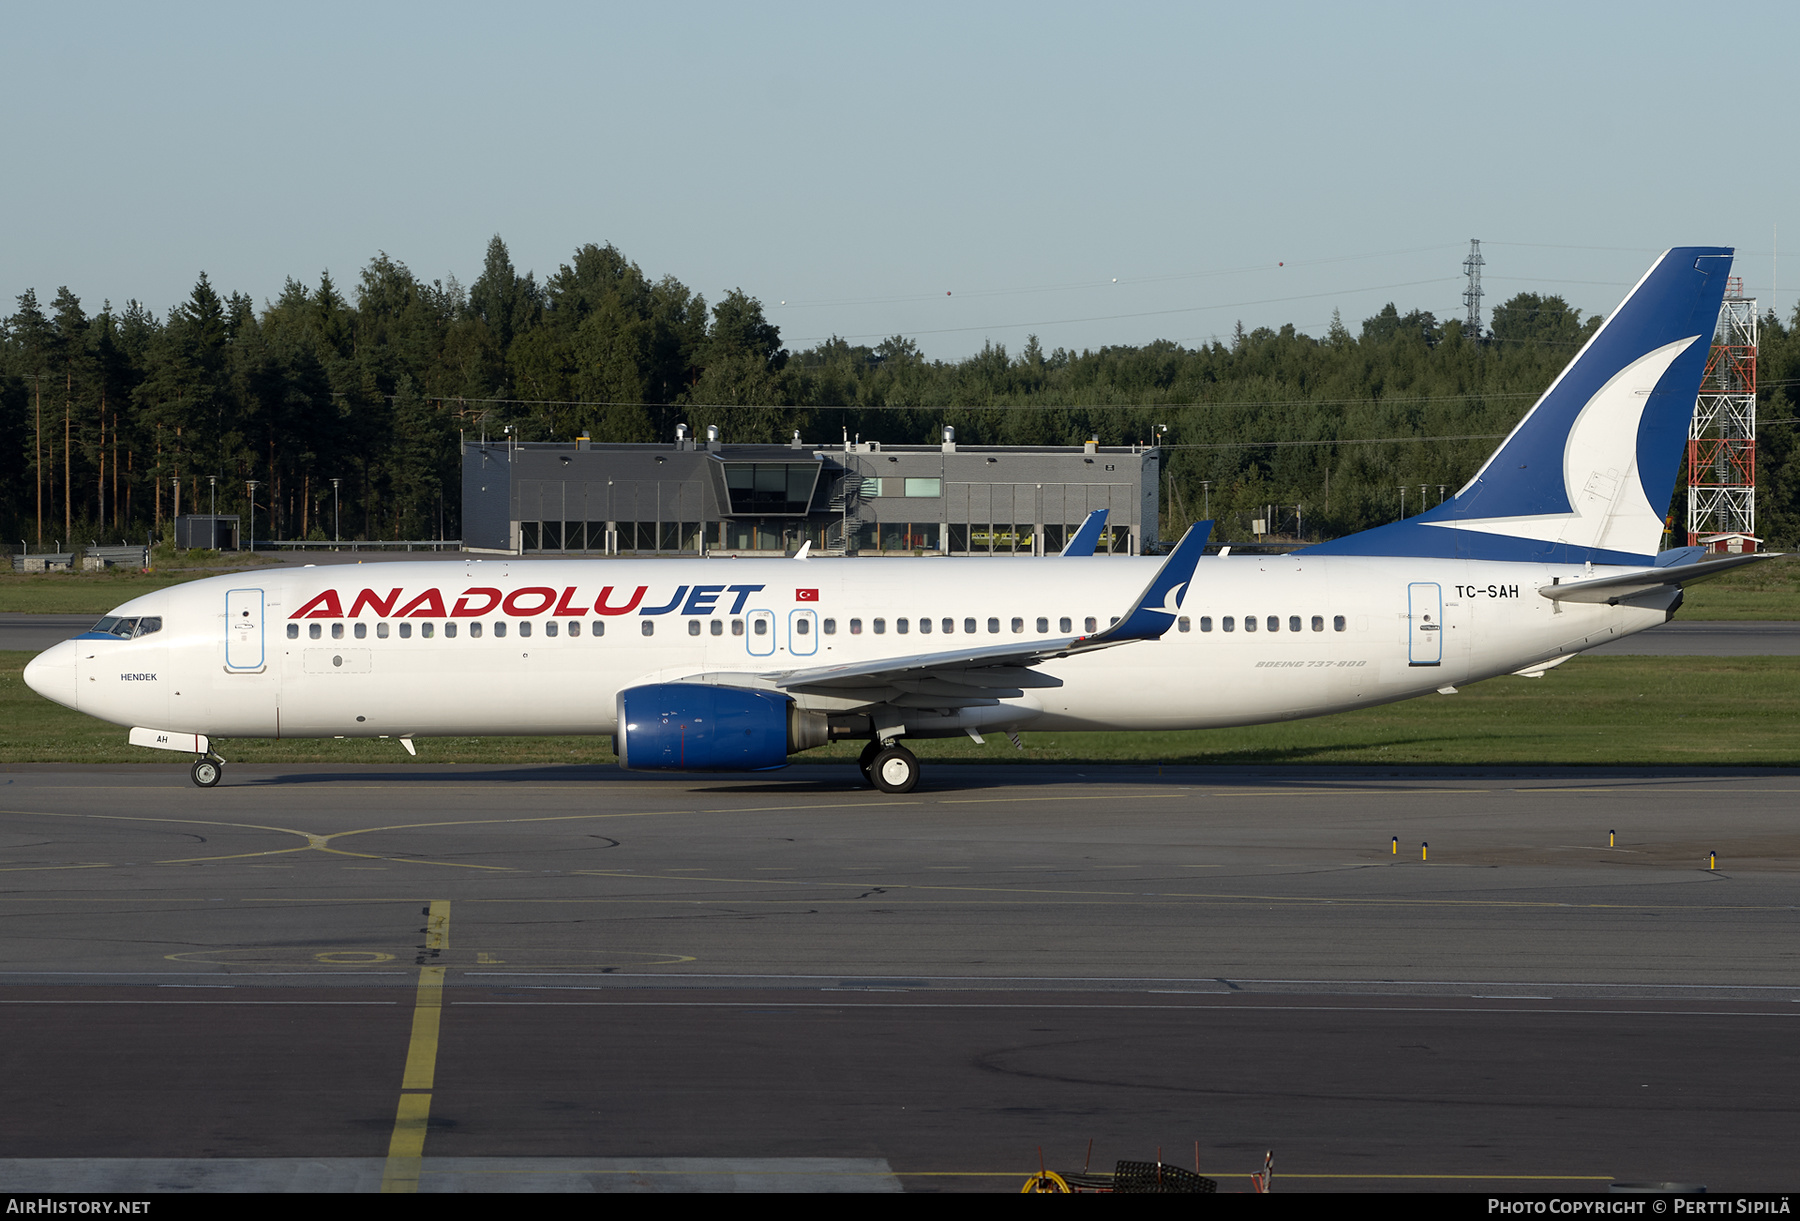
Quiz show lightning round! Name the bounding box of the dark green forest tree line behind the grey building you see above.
[0,238,1800,551]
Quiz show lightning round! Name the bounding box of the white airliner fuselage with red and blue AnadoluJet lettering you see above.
[31,555,1667,738]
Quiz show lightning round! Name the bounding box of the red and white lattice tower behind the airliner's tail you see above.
[1687,276,1757,551]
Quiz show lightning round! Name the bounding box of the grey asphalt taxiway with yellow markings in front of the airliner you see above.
[0,764,1800,1190]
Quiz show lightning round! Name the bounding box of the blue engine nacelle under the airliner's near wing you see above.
[614,683,828,771]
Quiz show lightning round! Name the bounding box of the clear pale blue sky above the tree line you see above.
[0,2,1800,358]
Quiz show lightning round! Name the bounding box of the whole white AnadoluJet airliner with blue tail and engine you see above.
[25,247,1759,792]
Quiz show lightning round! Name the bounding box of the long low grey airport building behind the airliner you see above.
[463,429,1161,555]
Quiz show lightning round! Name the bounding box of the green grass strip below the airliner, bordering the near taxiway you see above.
[0,652,1800,767]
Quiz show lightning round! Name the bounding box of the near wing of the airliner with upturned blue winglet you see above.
[759,522,1213,708]
